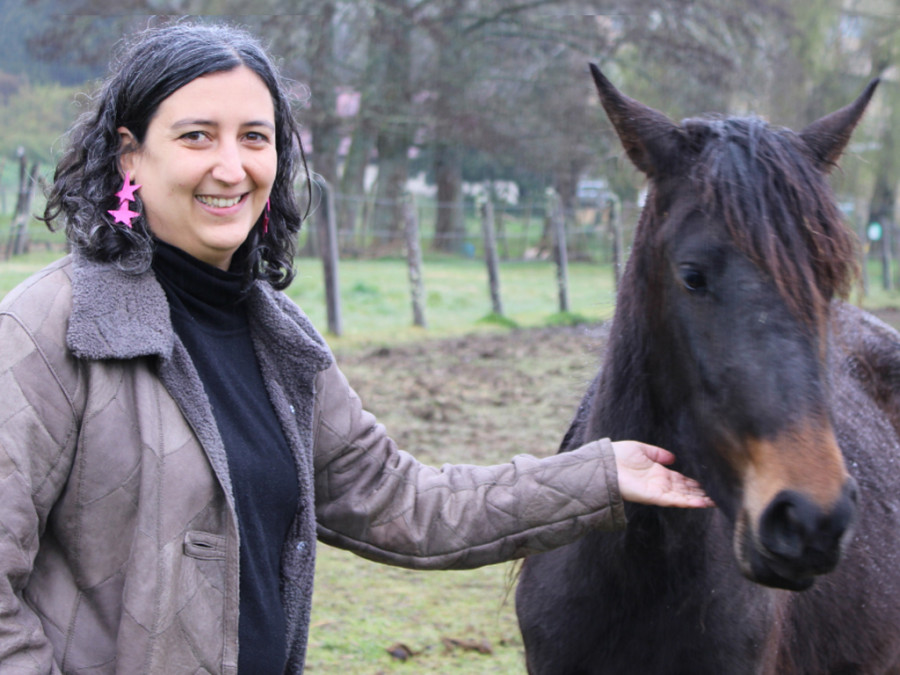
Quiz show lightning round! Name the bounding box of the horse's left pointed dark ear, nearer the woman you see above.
[590,63,682,178]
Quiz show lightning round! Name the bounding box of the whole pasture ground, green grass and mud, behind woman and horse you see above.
[0,252,900,675]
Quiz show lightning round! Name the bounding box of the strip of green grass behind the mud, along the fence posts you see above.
[288,257,614,346]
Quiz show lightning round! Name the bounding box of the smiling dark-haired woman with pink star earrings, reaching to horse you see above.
[0,24,710,673]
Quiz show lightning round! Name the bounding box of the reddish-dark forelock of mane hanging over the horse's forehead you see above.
[682,117,857,323]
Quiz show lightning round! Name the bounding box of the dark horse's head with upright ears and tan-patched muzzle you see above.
[591,65,876,590]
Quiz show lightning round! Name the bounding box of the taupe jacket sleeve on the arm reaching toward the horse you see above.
[313,366,625,569]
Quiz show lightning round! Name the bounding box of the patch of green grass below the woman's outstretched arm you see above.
[307,545,525,675]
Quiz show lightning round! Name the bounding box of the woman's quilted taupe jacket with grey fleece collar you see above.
[0,257,625,674]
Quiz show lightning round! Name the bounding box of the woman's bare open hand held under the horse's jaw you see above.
[612,441,715,508]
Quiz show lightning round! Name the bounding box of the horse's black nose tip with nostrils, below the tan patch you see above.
[739,477,859,591]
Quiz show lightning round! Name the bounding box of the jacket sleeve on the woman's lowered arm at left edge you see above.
[0,312,77,673]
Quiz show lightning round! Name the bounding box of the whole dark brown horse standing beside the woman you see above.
[516,66,900,675]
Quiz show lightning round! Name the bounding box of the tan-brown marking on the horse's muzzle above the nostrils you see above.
[743,420,849,523]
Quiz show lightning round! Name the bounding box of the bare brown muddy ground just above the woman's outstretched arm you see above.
[338,309,900,464]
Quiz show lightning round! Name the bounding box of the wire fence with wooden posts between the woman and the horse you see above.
[306,186,624,335]
